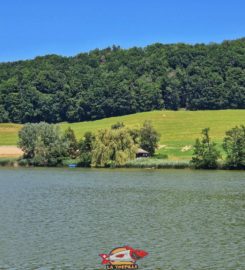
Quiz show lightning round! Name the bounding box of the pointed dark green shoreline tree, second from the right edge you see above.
[191,128,220,169]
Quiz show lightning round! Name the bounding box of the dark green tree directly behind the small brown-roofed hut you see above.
[139,121,160,156]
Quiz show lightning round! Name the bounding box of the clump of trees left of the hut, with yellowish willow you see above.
[18,121,160,167]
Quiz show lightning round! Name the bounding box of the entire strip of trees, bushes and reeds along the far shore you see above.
[0,121,241,170]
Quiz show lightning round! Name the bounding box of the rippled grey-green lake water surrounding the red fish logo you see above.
[0,168,245,270]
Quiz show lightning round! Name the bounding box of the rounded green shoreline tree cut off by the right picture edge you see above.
[223,126,245,169]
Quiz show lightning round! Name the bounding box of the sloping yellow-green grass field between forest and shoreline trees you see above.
[0,110,245,160]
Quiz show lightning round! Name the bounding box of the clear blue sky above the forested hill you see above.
[0,0,245,62]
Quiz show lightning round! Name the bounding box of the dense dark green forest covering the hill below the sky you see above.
[0,38,245,123]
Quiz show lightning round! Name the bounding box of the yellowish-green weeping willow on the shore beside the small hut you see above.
[92,128,137,167]
